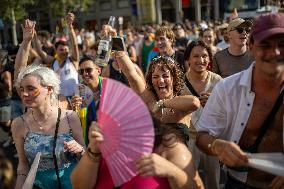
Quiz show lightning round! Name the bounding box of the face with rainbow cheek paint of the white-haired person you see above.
[20,75,50,108]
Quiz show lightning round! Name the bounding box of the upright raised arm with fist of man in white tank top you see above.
[66,12,79,70]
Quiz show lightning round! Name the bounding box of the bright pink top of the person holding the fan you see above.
[94,159,170,189]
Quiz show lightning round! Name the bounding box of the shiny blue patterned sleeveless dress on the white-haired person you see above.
[22,114,78,189]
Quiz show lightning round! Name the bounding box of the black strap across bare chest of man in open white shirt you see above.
[249,90,284,153]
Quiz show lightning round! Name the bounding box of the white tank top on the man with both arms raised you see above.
[52,58,79,97]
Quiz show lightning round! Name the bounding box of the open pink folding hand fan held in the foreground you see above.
[98,79,154,186]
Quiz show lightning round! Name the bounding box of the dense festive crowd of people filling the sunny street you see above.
[0,13,284,189]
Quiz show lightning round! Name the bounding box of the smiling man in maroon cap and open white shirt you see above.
[196,13,284,189]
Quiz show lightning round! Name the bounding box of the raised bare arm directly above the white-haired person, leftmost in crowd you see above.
[14,20,35,83]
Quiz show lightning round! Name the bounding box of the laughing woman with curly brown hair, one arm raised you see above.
[116,52,200,126]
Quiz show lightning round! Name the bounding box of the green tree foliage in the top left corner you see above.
[0,0,34,21]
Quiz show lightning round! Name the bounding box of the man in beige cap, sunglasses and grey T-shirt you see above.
[212,18,253,78]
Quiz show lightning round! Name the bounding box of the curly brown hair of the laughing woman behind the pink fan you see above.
[146,56,184,98]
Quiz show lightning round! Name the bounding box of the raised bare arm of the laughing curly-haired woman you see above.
[115,51,146,95]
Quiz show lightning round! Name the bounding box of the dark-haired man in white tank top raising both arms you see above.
[34,13,79,98]
